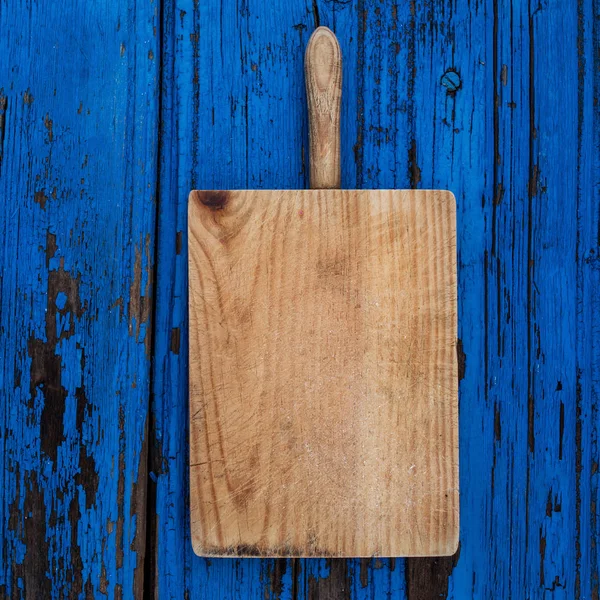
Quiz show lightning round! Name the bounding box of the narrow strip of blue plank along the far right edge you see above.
[576,0,600,598]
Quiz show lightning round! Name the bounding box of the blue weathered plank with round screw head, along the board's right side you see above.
[405,2,493,599]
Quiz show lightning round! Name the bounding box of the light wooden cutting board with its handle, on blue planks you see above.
[188,28,458,556]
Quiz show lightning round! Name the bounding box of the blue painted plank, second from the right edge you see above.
[522,2,579,599]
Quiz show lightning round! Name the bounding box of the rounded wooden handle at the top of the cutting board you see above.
[304,27,342,190]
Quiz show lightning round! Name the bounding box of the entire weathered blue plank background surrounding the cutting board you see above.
[0,0,600,600]
